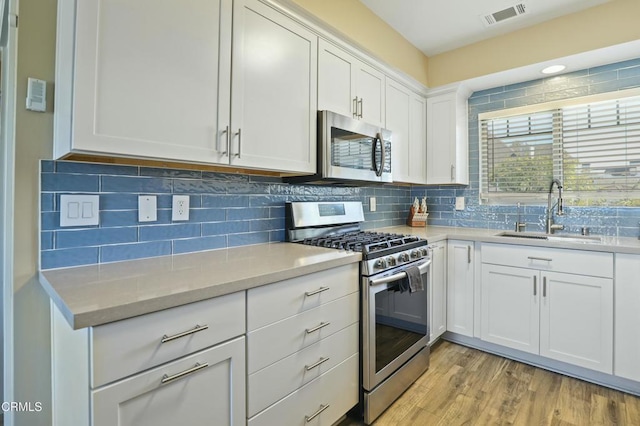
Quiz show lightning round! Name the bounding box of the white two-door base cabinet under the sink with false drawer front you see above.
[480,244,613,374]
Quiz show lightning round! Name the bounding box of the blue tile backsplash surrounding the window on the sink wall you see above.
[411,58,640,237]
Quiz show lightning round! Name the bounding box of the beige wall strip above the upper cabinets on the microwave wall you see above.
[292,0,428,86]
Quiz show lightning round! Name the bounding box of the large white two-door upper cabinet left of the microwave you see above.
[54,0,317,172]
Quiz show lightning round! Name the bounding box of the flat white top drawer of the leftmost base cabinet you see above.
[91,292,245,388]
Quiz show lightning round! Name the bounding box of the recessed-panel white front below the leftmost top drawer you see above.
[92,337,246,426]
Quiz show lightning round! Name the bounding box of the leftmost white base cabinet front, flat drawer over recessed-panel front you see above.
[89,292,246,426]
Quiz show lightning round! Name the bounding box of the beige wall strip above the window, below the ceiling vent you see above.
[428,0,640,87]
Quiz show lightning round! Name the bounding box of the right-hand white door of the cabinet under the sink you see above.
[540,272,613,374]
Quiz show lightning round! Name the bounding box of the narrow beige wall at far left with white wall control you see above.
[14,0,57,426]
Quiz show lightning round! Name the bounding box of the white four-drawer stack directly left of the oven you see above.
[247,264,359,426]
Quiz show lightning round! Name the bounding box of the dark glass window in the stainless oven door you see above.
[375,286,427,373]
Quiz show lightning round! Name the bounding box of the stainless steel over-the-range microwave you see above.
[287,111,392,184]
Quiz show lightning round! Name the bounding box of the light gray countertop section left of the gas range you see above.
[40,243,362,329]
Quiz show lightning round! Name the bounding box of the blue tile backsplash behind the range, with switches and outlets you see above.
[40,160,411,269]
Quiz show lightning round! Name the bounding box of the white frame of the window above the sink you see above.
[477,88,640,205]
